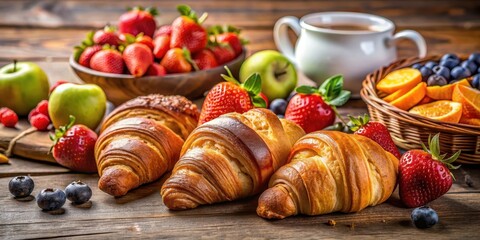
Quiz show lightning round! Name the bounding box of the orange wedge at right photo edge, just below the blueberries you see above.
[452,84,480,118]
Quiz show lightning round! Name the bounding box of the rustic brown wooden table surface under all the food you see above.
[0,0,480,239]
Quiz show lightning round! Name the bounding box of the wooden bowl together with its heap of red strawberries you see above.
[69,5,246,105]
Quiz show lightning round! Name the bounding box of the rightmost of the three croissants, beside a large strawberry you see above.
[257,131,398,219]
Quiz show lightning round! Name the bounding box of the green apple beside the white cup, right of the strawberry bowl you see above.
[240,50,297,100]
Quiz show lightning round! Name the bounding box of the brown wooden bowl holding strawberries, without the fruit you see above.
[69,49,246,106]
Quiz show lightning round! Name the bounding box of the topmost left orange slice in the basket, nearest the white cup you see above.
[377,68,422,94]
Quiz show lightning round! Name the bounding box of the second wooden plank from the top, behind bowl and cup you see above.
[0,27,480,59]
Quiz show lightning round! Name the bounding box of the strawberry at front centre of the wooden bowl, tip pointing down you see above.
[123,43,153,77]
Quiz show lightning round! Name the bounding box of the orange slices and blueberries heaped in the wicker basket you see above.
[376,53,480,126]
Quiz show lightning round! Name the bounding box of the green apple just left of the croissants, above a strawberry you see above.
[48,83,107,130]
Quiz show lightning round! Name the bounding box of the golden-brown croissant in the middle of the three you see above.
[161,109,305,210]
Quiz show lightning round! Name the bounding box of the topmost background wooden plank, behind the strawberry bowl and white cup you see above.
[0,0,480,29]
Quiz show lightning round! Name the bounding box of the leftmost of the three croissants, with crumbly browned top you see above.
[95,95,199,196]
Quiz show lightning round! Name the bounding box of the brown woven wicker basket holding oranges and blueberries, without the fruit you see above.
[360,56,480,164]
